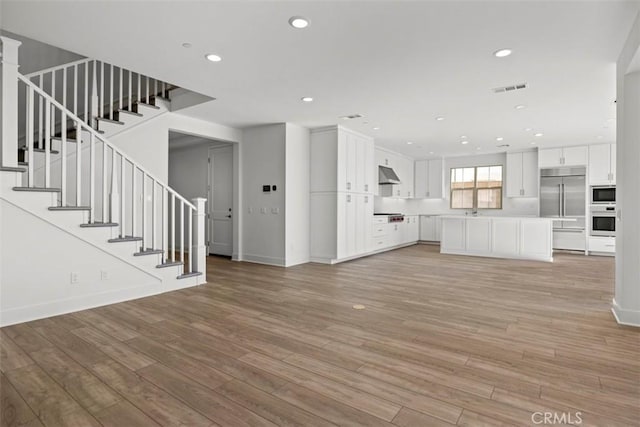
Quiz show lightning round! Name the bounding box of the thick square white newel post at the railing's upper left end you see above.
[0,36,22,167]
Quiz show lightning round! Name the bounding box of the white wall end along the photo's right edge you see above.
[613,14,640,326]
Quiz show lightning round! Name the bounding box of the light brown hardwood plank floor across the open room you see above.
[0,245,640,427]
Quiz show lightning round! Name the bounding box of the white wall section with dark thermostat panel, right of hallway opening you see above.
[241,123,286,265]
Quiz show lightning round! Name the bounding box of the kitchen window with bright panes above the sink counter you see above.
[450,165,502,209]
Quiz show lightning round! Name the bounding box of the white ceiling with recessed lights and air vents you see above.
[1,0,640,158]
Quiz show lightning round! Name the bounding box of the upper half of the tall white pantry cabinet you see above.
[311,126,378,194]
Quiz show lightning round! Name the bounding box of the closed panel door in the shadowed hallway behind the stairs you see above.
[208,146,233,256]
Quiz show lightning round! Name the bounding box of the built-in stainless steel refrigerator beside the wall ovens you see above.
[540,167,586,250]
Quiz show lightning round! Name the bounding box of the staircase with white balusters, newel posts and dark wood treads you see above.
[0,37,206,326]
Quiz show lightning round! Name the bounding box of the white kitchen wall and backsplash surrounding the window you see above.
[374,153,538,216]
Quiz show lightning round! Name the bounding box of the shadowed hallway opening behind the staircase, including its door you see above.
[169,131,235,258]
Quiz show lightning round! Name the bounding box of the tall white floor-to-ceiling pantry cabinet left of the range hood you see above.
[310,126,377,264]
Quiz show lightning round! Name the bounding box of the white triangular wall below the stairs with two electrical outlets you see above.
[0,198,162,325]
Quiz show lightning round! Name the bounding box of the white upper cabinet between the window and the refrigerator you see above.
[506,151,538,197]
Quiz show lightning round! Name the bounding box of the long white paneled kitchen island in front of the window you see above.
[440,215,553,262]
